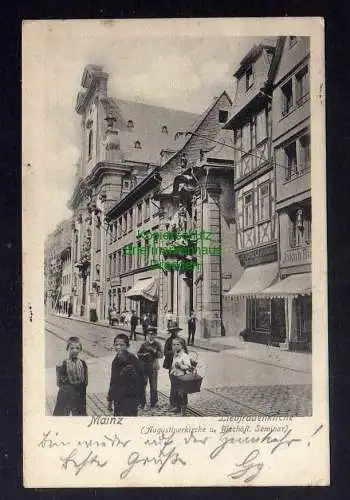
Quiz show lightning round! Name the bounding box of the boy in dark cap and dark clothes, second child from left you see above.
[107,333,144,417]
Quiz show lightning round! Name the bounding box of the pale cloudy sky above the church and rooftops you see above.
[38,21,274,234]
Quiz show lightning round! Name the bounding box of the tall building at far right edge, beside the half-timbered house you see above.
[265,36,312,350]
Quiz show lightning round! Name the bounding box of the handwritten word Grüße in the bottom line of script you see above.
[120,441,187,479]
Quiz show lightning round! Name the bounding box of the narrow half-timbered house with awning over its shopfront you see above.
[225,43,284,342]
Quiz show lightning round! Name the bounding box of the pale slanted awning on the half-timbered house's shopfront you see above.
[227,262,278,297]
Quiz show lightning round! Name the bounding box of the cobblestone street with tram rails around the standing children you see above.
[46,317,312,417]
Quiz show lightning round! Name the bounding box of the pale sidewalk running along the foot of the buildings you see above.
[50,314,312,373]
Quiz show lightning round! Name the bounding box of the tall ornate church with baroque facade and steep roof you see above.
[69,65,197,318]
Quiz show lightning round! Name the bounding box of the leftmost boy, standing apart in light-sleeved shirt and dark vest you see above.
[53,337,88,417]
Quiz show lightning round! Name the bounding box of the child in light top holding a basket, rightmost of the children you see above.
[170,338,192,415]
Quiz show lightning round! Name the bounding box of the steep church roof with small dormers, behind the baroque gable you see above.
[109,98,198,164]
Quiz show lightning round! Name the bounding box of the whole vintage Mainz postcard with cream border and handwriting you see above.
[22,18,329,488]
